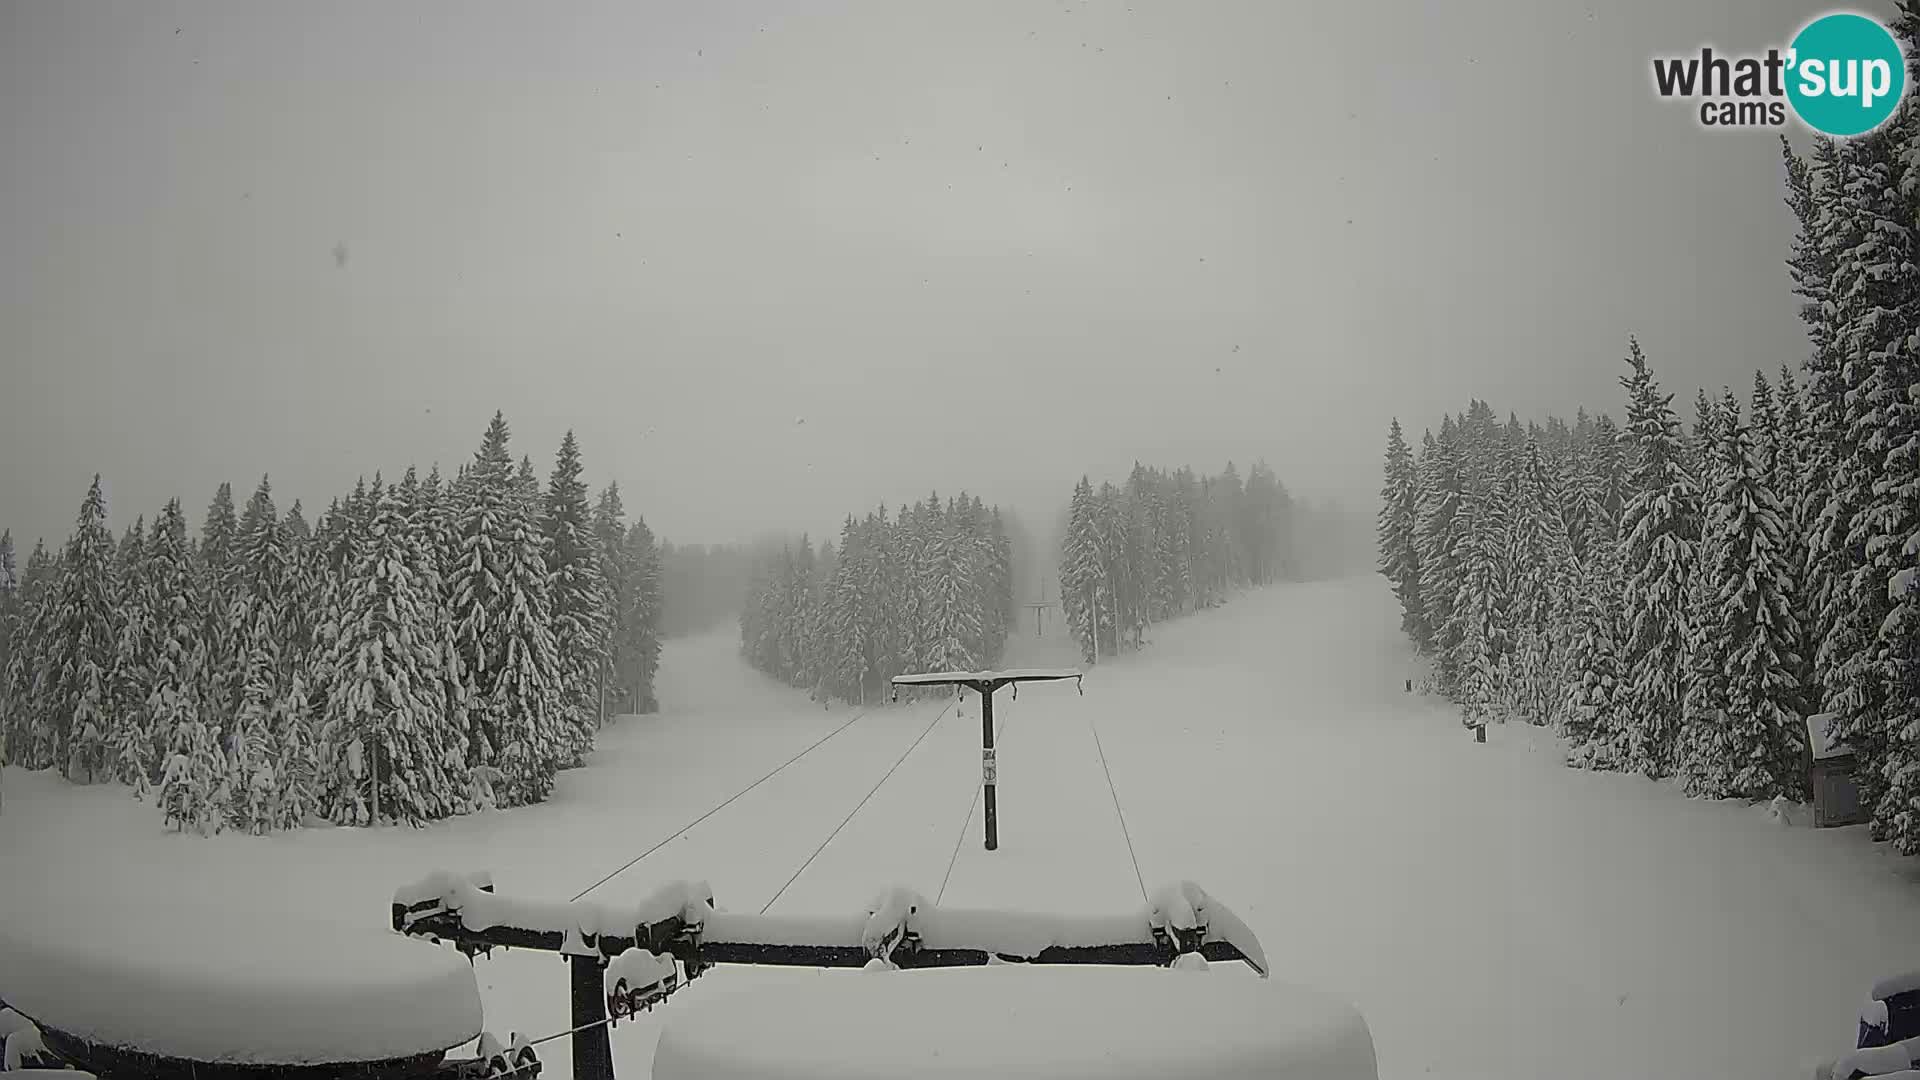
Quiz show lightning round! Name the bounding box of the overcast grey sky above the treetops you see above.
[0,0,1850,550]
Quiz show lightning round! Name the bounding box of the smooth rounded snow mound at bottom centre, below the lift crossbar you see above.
[653,965,1379,1080]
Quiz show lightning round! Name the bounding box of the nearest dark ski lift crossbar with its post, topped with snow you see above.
[392,872,1267,1080]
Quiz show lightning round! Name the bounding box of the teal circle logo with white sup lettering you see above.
[1788,12,1907,136]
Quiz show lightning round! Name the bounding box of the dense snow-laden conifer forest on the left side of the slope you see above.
[0,415,662,822]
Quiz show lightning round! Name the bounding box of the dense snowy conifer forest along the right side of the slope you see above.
[1379,127,1920,855]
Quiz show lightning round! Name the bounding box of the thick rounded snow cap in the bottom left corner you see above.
[0,896,482,1065]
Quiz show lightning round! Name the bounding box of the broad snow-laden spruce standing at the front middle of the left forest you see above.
[321,471,465,824]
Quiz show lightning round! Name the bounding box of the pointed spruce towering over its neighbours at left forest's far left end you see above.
[19,477,117,784]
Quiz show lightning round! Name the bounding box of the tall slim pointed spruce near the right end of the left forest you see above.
[541,430,612,753]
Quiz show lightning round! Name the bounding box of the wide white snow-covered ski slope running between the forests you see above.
[11,578,1920,1080]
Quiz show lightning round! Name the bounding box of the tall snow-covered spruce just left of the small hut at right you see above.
[1688,392,1805,799]
